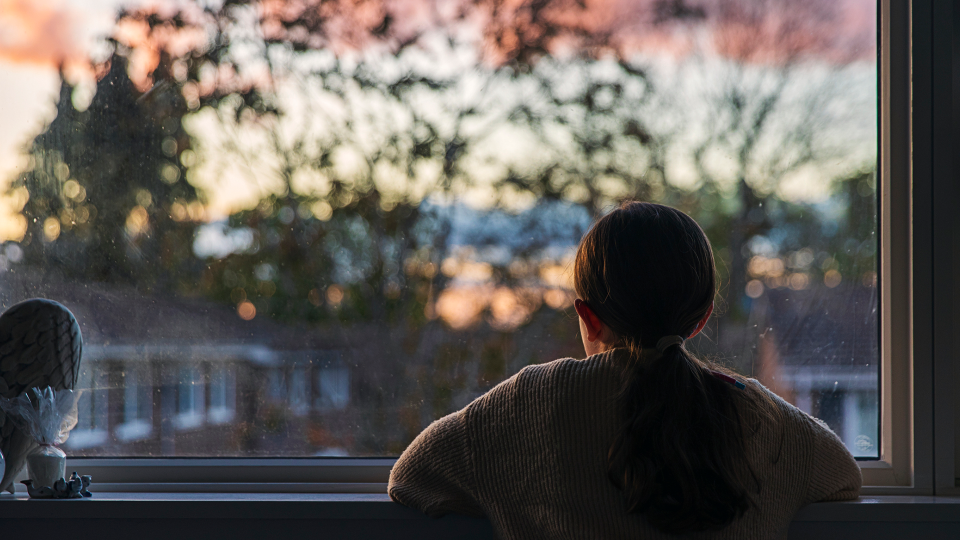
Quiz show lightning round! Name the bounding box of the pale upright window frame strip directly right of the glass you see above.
[860,0,921,493]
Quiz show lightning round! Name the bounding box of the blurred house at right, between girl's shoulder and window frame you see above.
[750,284,880,458]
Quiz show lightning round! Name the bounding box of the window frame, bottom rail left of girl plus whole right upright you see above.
[60,0,944,495]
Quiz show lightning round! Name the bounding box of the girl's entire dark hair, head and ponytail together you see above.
[574,202,757,533]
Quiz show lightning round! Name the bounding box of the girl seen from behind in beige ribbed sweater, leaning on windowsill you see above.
[388,202,861,539]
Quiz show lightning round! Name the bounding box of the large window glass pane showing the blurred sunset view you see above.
[0,0,880,458]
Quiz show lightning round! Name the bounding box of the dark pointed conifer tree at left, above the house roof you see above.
[11,55,198,291]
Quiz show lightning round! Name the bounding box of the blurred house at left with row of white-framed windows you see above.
[0,272,355,456]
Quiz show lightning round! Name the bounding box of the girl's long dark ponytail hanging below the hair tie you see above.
[608,344,756,534]
